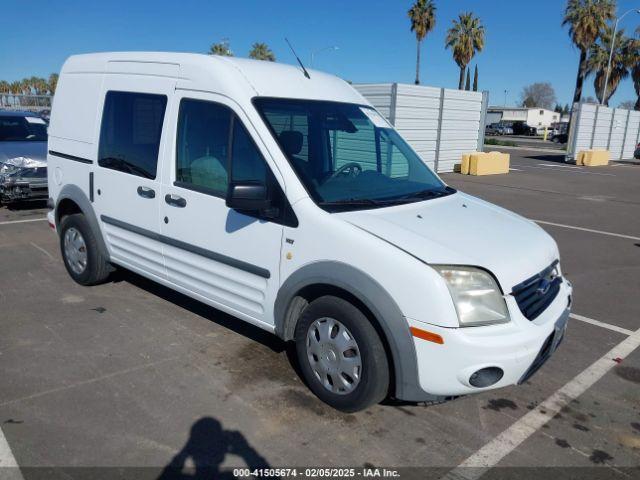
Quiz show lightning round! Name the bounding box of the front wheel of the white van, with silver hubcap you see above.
[295,296,389,412]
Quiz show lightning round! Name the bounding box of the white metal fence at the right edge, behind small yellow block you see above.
[567,103,640,161]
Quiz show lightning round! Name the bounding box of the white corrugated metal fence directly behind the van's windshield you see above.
[354,83,489,172]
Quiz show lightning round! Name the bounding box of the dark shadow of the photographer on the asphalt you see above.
[158,417,269,480]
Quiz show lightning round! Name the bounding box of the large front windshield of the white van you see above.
[254,98,455,211]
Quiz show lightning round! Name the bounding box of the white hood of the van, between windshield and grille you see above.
[338,193,558,293]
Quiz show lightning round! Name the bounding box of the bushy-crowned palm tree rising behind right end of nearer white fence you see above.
[445,12,484,90]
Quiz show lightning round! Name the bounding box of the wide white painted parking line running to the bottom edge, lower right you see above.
[444,330,640,480]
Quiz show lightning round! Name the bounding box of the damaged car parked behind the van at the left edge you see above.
[0,111,48,203]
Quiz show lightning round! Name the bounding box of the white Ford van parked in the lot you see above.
[48,53,571,411]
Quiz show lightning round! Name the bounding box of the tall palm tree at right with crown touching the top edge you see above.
[562,0,616,103]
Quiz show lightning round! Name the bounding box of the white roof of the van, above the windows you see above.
[61,52,368,105]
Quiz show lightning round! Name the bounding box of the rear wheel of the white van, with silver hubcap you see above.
[60,213,111,285]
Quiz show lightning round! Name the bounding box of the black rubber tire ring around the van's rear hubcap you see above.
[59,213,113,286]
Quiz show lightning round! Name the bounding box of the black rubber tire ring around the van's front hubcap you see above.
[295,296,389,412]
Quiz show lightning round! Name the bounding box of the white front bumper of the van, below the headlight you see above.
[407,280,572,396]
